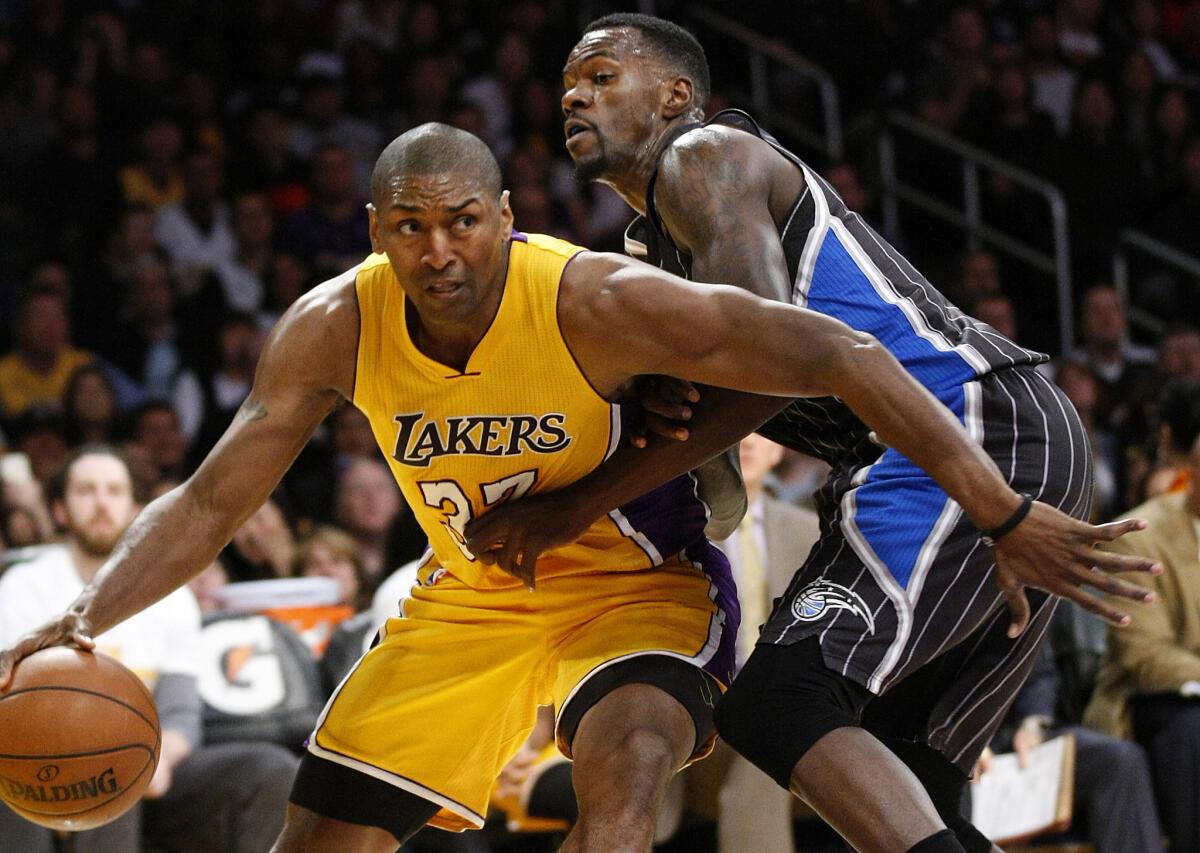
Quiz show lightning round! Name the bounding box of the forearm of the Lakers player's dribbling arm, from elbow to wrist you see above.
[70,483,244,636]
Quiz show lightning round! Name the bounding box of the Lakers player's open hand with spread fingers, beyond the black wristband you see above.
[995,501,1163,637]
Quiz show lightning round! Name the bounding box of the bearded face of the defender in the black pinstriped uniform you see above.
[563,28,662,181]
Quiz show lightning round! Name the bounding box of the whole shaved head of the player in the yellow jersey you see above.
[370,122,512,322]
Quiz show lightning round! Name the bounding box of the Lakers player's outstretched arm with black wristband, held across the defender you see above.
[472,254,1154,630]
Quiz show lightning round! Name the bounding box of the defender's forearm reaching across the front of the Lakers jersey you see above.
[569,388,790,516]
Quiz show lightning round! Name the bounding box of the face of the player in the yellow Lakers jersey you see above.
[371,175,512,323]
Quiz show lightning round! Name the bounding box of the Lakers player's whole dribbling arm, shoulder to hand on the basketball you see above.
[0,282,359,687]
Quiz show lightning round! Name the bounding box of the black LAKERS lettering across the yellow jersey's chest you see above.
[392,412,571,468]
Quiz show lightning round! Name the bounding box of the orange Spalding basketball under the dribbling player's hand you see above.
[0,648,161,831]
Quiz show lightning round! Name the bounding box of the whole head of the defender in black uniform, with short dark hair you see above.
[563,13,709,181]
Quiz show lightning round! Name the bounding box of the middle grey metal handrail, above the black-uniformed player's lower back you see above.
[880,110,1075,353]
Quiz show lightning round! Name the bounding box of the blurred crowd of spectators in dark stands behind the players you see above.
[0,0,1200,849]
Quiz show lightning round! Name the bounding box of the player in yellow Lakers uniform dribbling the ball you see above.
[0,125,1148,853]
